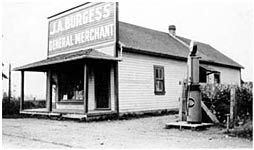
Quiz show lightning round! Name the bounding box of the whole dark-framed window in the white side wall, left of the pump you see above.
[154,66,165,95]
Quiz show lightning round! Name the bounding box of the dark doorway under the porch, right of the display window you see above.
[94,64,110,109]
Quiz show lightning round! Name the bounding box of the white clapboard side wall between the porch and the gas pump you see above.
[119,52,186,112]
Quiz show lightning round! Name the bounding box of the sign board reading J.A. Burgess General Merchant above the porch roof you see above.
[48,2,117,57]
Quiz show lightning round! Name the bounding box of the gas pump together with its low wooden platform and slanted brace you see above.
[166,41,214,130]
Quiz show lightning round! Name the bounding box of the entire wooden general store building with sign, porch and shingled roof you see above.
[15,3,243,119]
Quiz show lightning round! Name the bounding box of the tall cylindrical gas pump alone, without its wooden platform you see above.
[186,41,202,123]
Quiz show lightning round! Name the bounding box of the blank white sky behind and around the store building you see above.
[1,0,254,98]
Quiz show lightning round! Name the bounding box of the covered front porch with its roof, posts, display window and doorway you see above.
[14,49,119,117]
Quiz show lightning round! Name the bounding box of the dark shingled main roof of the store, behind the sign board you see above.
[119,22,243,68]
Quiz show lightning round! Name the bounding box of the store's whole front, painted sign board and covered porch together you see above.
[16,3,120,117]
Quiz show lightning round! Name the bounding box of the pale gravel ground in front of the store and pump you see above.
[2,115,252,148]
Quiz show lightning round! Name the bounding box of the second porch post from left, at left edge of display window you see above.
[46,69,52,112]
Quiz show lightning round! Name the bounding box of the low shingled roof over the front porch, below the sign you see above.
[13,49,120,71]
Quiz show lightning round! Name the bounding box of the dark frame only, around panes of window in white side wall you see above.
[153,65,166,95]
